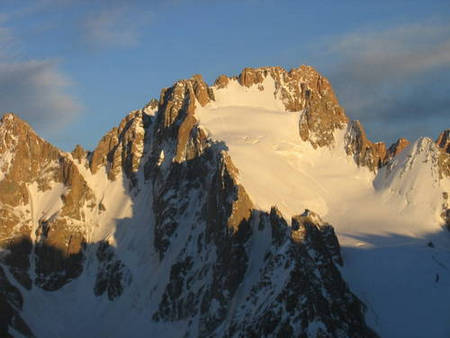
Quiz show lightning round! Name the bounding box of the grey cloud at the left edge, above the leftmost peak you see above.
[0,0,82,134]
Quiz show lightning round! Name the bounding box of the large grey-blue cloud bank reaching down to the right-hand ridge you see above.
[326,22,450,140]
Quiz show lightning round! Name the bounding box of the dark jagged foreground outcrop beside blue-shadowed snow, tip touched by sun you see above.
[225,208,376,337]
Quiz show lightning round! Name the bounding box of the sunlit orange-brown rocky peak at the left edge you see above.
[0,114,92,210]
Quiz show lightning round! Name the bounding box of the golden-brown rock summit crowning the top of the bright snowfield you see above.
[214,65,349,148]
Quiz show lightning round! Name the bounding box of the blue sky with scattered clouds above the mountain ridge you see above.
[0,0,450,150]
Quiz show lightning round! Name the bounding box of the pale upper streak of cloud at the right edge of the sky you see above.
[329,23,450,83]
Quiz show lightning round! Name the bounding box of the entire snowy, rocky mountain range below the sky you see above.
[0,66,450,337]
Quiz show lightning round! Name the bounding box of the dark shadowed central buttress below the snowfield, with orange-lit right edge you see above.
[148,146,376,337]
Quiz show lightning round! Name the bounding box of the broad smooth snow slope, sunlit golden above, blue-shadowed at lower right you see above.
[196,76,450,337]
